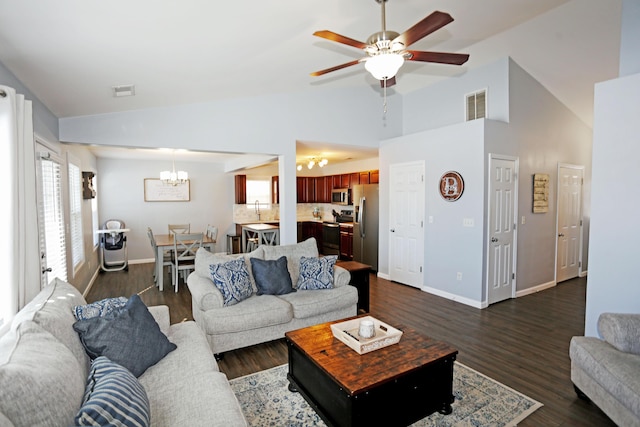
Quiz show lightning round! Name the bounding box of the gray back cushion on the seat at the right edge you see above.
[598,313,640,355]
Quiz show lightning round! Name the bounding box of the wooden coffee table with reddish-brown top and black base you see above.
[285,319,458,426]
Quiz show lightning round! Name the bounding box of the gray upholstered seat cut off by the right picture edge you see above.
[569,313,640,426]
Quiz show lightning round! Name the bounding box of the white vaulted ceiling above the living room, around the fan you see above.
[0,0,621,165]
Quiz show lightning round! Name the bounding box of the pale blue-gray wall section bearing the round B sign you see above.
[378,120,485,307]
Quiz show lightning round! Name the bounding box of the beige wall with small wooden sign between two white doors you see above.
[487,61,592,292]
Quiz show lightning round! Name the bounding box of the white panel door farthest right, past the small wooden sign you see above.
[556,166,583,283]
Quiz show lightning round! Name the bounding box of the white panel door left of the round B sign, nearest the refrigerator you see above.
[389,162,424,288]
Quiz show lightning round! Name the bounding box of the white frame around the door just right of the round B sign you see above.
[483,153,520,307]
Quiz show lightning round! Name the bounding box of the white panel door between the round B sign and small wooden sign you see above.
[487,156,518,304]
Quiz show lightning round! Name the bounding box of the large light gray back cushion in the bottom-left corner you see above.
[0,322,86,427]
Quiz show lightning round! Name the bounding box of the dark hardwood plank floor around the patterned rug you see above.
[87,264,615,426]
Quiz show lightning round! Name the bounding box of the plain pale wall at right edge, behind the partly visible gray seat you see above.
[585,74,640,336]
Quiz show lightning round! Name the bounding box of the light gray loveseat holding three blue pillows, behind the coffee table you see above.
[187,237,358,354]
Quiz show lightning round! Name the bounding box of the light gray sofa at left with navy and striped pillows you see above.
[0,280,247,427]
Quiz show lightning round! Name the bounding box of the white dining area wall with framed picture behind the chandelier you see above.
[96,159,235,261]
